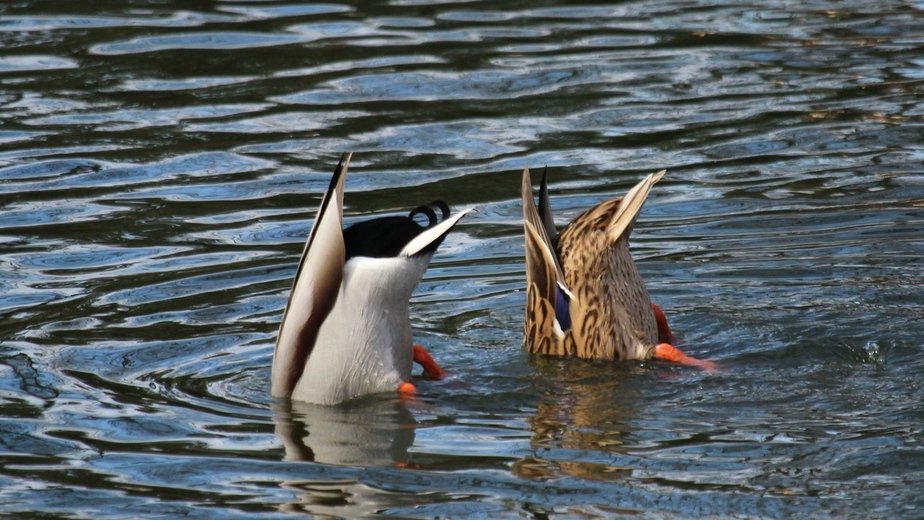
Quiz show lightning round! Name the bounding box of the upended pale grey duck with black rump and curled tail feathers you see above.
[270,153,471,405]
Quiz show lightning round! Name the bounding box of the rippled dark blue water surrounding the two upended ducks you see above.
[0,0,924,518]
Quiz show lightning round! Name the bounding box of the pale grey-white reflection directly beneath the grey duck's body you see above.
[273,397,417,466]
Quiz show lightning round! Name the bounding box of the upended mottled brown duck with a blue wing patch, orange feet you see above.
[521,168,715,370]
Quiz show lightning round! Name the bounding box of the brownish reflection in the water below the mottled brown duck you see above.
[512,358,635,480]
